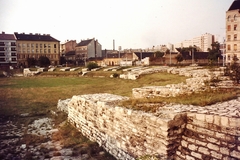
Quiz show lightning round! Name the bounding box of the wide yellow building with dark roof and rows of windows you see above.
[14,32,60,66]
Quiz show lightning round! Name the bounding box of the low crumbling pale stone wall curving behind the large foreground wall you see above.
[132,67,233,98]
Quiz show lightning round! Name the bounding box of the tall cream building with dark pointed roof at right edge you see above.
[226,0,240,63]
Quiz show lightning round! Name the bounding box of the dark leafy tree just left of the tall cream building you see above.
[208,42,221,65]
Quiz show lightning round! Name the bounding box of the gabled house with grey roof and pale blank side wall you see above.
[76,38,102,61]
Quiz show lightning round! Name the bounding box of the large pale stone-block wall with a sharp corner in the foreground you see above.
[58,68,240,160]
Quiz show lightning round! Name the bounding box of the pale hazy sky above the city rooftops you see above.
[0,0,234,49]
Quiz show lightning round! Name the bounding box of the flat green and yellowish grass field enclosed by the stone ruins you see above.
[0,72,186,115]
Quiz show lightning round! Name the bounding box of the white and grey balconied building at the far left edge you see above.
[0,32,17,66]
